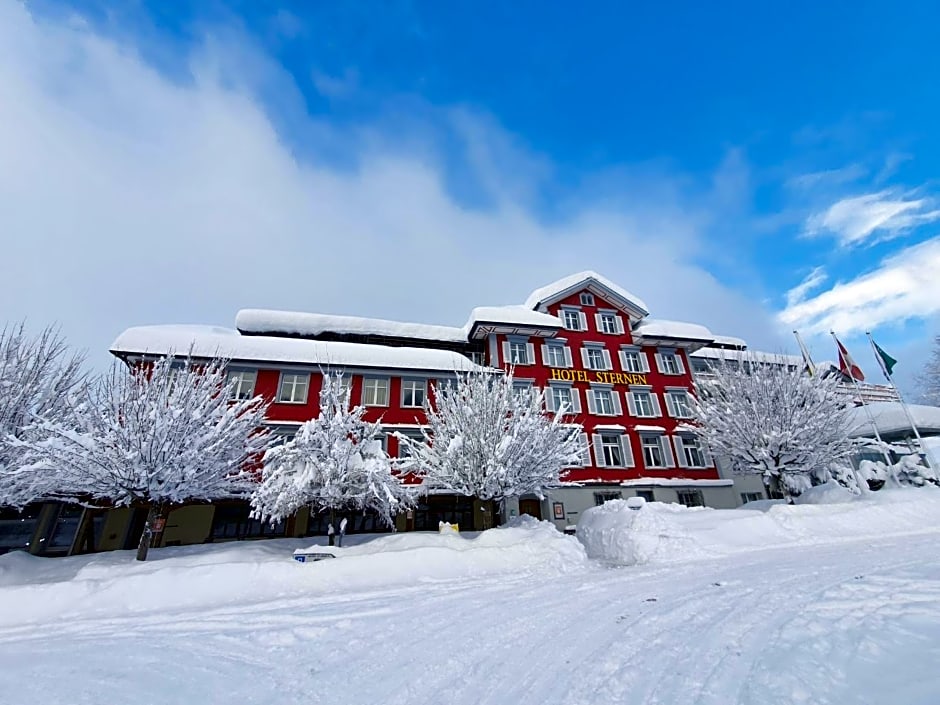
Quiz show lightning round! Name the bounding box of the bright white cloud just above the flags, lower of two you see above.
[779,237,940,335]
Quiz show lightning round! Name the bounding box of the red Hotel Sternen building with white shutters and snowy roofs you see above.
[111,272,738,543]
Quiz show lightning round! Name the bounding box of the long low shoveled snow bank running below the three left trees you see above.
[0,517,589,624]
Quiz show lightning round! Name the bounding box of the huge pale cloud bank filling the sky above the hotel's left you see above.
[0,3,773,362]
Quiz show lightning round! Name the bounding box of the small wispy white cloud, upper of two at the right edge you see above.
[806,189,940,246]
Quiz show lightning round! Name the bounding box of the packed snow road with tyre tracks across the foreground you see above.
[0,532,940,705]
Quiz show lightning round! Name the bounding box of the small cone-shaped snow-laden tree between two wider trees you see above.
[251,373,414,539]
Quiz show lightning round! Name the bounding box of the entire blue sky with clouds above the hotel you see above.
[0,0,940,390]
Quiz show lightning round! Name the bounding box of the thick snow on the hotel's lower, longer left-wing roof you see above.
[111,325,484,372]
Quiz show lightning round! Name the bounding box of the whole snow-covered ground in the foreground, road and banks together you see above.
[0,490,940,705]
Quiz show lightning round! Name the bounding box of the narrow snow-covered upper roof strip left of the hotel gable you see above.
[235,308,467,343]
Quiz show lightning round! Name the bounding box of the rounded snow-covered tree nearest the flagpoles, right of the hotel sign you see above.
[694,353,853,496]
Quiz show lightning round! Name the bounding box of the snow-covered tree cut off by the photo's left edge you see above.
[0,324,85,507]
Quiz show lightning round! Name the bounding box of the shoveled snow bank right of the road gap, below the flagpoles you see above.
[577,485,940,565]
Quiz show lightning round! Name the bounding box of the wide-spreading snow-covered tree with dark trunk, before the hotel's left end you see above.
[23,355,271,560]
